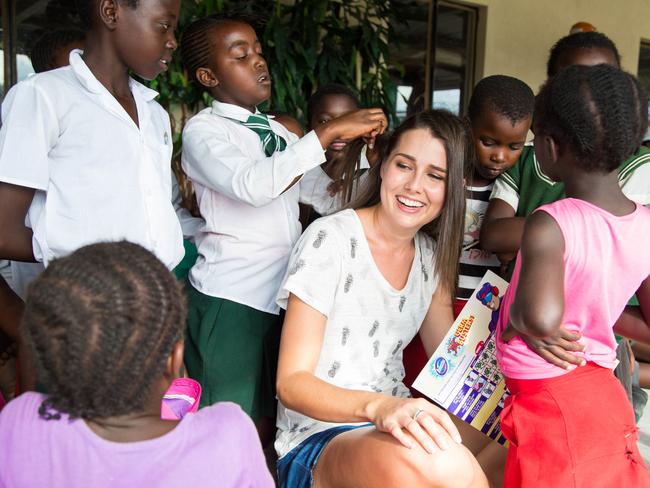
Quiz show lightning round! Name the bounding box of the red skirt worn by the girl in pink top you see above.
[501,363,650,488]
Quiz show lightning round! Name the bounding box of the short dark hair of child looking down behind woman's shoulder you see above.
[467,75,535,125]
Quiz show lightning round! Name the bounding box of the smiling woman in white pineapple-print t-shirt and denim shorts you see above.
[275,110,487,487]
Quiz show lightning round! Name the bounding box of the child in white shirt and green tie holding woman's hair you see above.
[181,16,387,442]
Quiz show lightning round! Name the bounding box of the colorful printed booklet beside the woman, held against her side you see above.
[413,271,509,444]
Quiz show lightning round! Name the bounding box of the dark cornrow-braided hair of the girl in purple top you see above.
[22,241,185,420]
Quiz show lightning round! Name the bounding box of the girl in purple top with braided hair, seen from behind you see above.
[0,241,273,487]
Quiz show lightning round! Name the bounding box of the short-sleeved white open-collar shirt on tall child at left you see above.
[0,50,183,269]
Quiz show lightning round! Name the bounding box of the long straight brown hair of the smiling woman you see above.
[346,110,471,299]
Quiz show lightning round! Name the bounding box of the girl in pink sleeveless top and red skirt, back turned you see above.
[497,65,650,487]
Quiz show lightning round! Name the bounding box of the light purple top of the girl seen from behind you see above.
[0,392,274,488]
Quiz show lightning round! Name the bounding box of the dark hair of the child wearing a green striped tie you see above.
[180,12,256,88]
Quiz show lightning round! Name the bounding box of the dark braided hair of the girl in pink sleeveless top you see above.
[534,64,648,172]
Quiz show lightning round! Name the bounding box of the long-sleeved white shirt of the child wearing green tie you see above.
[181,101,325,314]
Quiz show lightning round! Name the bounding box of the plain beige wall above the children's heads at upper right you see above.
[458,0,650,91]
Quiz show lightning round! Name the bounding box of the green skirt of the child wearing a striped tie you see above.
[185,283,281,421]
